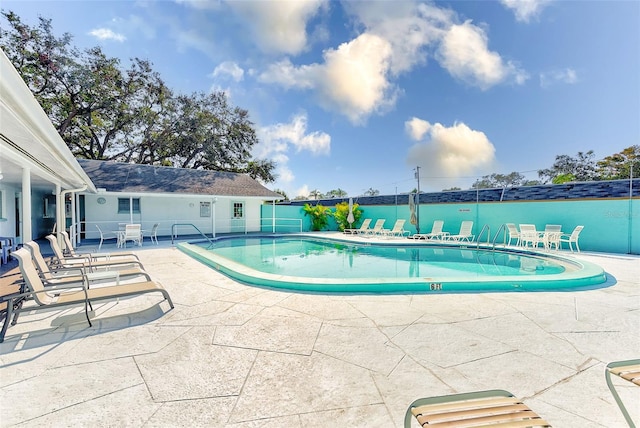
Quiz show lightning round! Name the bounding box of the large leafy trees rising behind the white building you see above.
[0,10,276,183]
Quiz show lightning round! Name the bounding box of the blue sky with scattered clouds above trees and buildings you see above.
[1,0,640,197]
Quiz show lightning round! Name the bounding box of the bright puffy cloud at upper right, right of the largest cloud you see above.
[438,21,528,90]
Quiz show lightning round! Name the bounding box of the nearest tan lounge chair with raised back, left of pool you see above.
[0,248,173,343]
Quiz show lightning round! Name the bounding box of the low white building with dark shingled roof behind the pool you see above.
[78,159,282,239]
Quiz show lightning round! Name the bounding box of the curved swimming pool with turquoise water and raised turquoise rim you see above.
[178,235,606,293]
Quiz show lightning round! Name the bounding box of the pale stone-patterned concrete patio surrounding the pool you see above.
[0,236,640,428]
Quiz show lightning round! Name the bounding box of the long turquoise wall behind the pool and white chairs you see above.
[262,195,640,254]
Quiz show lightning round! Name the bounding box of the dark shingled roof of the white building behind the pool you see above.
[78,159,281,199]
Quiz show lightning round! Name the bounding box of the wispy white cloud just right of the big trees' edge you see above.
[252,113,331,187]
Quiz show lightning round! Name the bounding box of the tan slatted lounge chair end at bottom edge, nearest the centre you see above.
[404,389,551,428]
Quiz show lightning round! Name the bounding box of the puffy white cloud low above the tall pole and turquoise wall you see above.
[405,118,495,184]
